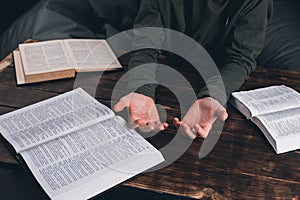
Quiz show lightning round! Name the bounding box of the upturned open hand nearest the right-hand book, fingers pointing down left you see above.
[173,97,228,139]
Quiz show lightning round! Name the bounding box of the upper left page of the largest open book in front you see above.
[0,88,114,153]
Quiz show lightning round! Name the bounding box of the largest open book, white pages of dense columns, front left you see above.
[0,88,164,200]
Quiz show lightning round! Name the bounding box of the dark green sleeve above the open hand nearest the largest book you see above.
[128,0,164,98]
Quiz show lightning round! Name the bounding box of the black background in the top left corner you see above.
[0,0,42,35]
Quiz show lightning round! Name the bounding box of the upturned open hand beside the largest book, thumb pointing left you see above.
[114,93,168,132]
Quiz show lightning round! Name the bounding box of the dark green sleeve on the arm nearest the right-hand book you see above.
[198,0,272,105]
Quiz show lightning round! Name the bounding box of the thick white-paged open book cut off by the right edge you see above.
[230,85,300,154]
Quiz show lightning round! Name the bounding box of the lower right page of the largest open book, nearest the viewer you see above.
[21,117,164,200]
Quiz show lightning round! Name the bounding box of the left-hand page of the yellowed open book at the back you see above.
[19,40,74,75]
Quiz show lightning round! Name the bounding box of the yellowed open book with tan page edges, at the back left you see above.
[13,39,122,85]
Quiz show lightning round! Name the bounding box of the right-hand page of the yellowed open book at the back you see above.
[64,39,122,72]
